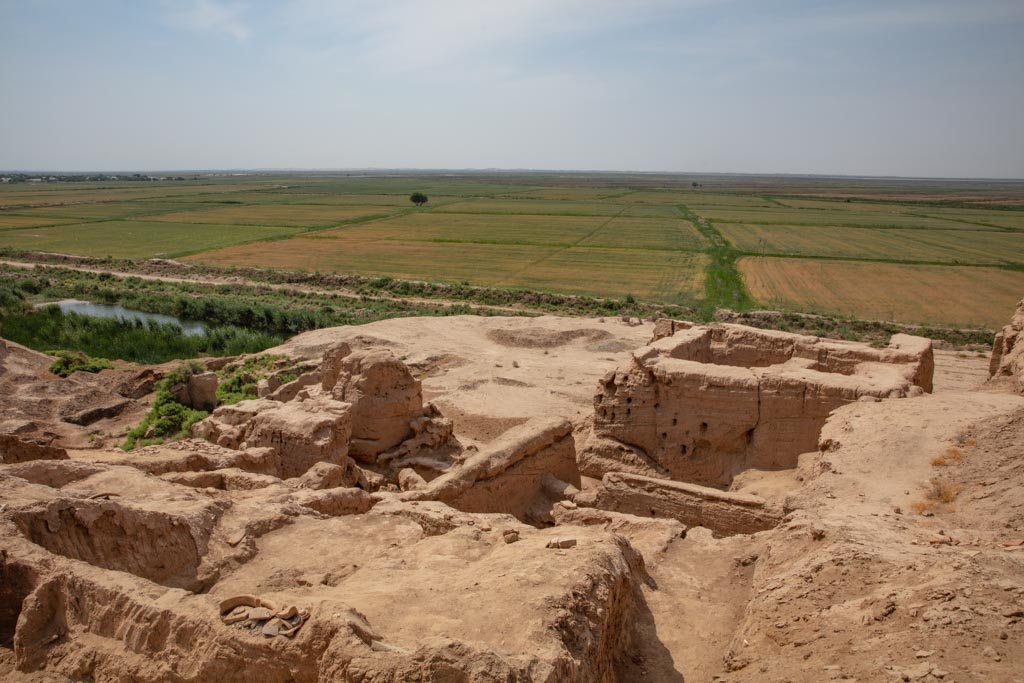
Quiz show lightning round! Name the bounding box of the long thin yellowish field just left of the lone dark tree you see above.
[153,204,386,227]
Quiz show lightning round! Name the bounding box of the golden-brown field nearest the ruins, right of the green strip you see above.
[739,257,1024,329]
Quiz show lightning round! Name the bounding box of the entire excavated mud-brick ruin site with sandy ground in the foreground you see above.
[0,302,1024,683]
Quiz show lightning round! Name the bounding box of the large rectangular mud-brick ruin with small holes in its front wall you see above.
[580,324,934,486]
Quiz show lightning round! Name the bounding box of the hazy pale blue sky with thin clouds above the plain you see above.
[0,0,1024,178]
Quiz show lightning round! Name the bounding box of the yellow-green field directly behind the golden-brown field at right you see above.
[716,223,1024,263]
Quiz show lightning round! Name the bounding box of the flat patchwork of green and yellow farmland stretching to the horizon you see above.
[0,172,1024,326]
